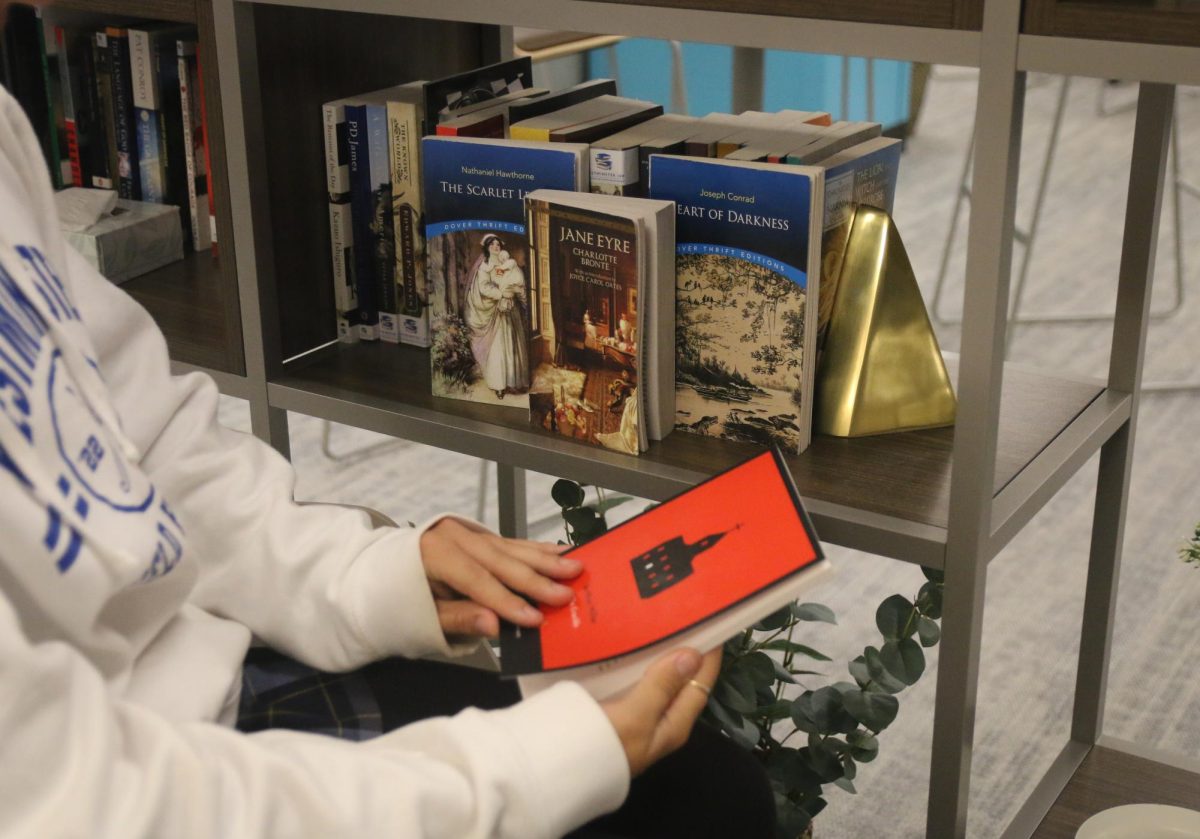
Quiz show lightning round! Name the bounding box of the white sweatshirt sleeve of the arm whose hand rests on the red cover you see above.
[65,242,458,670]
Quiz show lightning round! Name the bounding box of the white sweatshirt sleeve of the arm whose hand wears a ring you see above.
[0,594,629,839]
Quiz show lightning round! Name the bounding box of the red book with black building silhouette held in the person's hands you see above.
[500,447,828,699]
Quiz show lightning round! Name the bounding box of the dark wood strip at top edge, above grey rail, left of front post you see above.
[590,0,983,30]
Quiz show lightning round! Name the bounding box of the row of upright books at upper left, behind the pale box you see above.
[5,8,215,251]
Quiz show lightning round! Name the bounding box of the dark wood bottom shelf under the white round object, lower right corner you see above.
[1032,745,1200,839]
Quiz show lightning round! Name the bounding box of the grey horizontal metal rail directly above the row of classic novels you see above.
[238,0,980,66]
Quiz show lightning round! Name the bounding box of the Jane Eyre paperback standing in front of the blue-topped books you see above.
[526,190,674,455]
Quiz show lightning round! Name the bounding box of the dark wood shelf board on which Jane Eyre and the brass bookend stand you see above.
[269,343,1103,567]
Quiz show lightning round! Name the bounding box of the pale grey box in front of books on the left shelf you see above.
[62,198,184,283]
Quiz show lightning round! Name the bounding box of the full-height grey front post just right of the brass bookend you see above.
[925,0,1025,839]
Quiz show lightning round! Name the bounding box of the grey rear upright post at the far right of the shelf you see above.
[1070,82,1175,745]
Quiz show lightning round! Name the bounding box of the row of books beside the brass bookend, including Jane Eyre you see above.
[325,59,900,454]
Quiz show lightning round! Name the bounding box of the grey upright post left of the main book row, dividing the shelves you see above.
[212,0,289,457]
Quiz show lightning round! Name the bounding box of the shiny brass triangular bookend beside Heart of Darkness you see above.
[814,205,958,437]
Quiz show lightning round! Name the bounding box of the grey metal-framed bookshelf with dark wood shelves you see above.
[25,0,1180,839]
